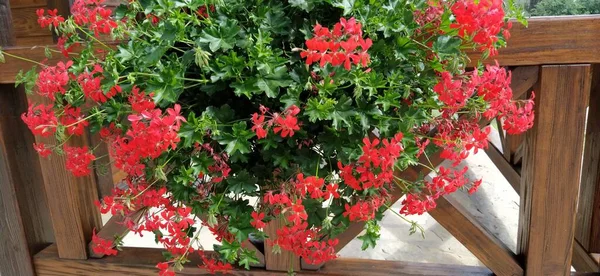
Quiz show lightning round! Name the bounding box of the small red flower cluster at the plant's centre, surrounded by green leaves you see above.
[252,105,300,139]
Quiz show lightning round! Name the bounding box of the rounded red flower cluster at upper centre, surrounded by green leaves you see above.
[300,17,373,70]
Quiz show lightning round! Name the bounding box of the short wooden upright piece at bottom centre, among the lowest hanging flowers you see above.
[263,220,300,271]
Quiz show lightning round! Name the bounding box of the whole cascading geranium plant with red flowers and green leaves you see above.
[5,0,533,275]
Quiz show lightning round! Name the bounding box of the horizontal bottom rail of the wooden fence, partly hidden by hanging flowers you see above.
[34,245,493,276]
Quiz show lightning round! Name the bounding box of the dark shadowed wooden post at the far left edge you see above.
[0,0,53,276]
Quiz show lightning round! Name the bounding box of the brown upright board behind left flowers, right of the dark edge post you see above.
[29,94,102,259]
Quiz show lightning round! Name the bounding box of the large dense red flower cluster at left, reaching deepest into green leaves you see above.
[111,88,185,176]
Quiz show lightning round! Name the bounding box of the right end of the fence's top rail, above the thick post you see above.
[471,15,600,66]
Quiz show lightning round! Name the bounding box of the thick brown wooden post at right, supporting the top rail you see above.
[517,65,591,275]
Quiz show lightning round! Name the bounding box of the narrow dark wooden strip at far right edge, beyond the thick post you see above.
[575,65,600,252]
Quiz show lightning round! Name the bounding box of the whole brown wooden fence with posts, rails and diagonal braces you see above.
[0,0,600,276]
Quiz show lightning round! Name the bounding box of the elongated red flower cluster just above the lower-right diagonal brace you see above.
[400,167,481,215]
